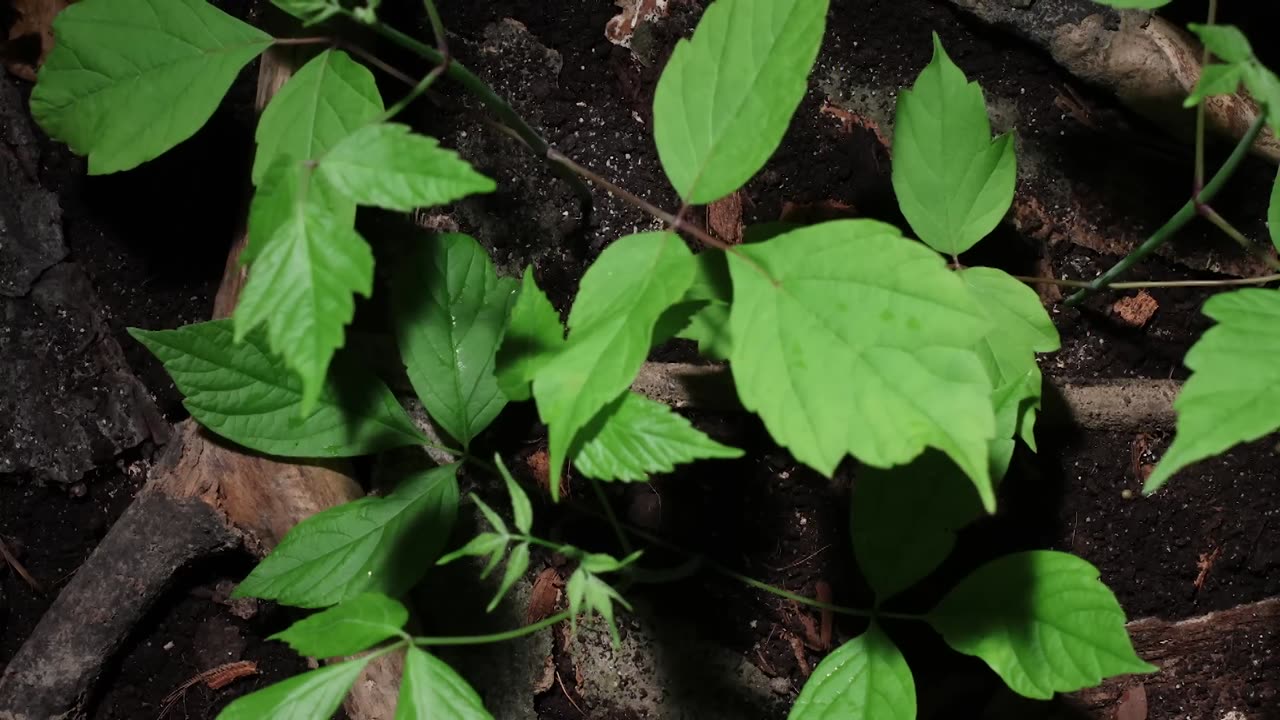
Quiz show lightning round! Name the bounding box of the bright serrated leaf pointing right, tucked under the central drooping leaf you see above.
[573,392,742,483]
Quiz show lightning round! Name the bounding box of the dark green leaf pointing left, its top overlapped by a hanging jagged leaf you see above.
[129,320,425,457]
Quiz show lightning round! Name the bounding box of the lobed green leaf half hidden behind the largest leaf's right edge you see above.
[959,268,1061,448]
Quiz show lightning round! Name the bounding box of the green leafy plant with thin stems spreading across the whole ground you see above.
[32,0,1280,720]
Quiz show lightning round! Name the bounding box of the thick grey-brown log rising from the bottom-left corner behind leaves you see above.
[0,47,402,720]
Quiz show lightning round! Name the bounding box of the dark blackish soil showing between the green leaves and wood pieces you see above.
[0,0,1280,720]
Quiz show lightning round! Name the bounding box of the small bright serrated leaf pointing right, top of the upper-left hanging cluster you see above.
[316,123,497,211]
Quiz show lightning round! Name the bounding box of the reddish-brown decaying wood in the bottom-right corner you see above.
[1071,598,1280,720]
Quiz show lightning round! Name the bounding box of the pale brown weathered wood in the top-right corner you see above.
[948,0,1280,163]
